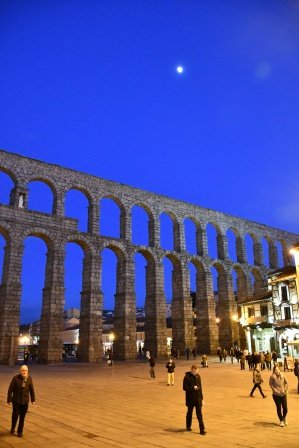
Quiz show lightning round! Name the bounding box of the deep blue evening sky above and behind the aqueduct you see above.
[0,0,299,320]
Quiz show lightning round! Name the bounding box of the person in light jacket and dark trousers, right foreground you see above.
[269,365,288,426]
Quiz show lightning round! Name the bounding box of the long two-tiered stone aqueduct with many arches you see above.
[0,151,298,363]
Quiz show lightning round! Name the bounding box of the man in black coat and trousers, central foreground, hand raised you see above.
[183,364,206,435]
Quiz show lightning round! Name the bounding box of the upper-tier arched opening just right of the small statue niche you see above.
[27,180,53,214]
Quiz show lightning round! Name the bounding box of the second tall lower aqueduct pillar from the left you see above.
[38,245,65,364]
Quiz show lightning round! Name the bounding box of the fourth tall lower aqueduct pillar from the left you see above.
[113,256,137,360]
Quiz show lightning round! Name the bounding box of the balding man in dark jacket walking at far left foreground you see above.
[7,365,35,437]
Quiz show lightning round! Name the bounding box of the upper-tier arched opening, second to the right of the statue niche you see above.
[65,189,89,232]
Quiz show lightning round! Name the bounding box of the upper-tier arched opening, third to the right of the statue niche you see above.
[100,198,121,238]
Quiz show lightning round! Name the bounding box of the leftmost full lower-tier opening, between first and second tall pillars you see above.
[20,236,47,325]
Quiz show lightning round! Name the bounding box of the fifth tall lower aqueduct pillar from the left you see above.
[145,260,167,358]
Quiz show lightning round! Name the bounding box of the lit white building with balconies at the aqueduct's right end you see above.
[239,244,299,357]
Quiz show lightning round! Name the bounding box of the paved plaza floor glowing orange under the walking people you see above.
[0,357,299,448]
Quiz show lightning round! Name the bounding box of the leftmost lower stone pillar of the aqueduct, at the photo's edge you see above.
[0,239,24,365]
